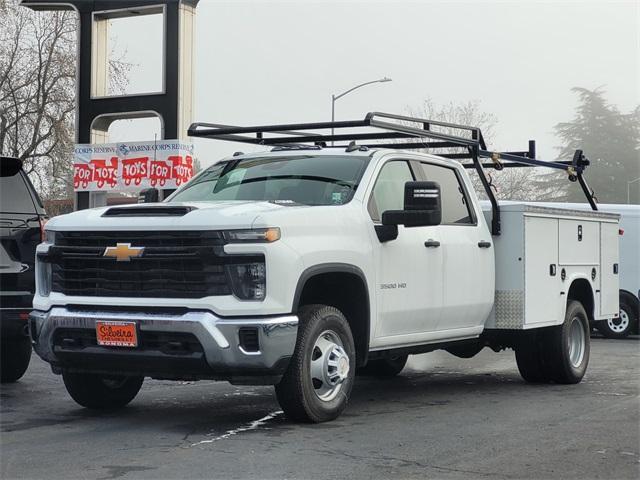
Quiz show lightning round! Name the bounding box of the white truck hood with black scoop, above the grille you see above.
[47,201,310,231]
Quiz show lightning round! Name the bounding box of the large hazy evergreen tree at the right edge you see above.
[541,87,640,204]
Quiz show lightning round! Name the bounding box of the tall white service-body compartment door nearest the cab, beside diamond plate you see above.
[524,216,564,326]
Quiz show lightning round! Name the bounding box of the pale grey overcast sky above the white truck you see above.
[110,0,640,165]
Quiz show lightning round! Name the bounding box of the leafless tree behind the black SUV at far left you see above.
[0,0,130,198]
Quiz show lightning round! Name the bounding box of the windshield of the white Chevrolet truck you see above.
[169,155,369,205]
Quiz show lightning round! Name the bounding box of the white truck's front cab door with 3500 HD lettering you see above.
[367,160,443,344]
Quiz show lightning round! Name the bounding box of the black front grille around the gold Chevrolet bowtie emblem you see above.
[47,231,264,298]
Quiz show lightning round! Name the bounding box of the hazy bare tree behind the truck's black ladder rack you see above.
[407,98,538,200]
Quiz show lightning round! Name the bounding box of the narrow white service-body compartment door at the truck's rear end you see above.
[599,222,619,317]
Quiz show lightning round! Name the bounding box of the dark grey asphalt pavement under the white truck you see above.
[0,337,640,480]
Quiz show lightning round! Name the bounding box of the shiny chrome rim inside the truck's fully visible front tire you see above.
[310,330,350,402]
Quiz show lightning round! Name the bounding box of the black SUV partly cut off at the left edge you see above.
[0,157,46,383]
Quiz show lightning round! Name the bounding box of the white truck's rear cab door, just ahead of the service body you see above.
[415,160,495,330]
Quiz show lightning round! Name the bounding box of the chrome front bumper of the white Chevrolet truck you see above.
[29,307,298,384]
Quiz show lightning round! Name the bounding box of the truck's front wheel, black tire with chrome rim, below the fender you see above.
[275,305,355,423]
